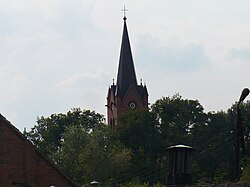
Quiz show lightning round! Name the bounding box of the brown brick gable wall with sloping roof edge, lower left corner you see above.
[0,115,75,187]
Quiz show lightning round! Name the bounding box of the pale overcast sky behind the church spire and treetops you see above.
[0,0,250,131]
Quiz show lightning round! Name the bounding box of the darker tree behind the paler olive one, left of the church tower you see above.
[24,108,104,159]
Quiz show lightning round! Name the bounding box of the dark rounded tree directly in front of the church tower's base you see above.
[116,110,162,162]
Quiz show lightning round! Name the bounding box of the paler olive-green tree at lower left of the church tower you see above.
[80,126,131,181]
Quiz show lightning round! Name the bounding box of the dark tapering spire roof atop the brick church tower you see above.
[116,17,137,97]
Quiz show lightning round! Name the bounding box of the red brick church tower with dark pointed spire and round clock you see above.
[106,16,148,129]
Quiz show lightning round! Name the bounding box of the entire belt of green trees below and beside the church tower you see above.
[25,94,250,187]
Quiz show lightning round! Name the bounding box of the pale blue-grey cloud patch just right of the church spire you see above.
[136,37,209,73]
